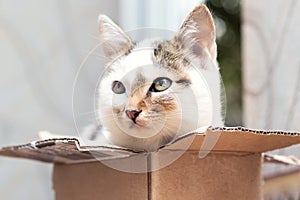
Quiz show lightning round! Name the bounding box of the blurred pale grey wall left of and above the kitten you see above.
[0,0,200,199]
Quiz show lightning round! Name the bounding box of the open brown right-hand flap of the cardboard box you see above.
[178,127,300,152]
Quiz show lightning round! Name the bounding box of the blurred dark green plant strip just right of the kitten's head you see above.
[206,0,242,126]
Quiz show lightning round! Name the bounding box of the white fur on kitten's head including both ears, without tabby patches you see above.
[92,5,223,150]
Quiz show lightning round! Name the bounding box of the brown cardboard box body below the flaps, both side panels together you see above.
[53,151,262,200]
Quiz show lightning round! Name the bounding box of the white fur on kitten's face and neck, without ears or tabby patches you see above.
[98,45,222,150]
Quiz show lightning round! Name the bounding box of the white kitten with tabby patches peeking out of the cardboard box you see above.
[90,4,223,151]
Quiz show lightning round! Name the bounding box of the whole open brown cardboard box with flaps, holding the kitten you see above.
[0,127,300,200]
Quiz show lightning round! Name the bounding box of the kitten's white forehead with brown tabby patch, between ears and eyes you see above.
[108,40,188,88]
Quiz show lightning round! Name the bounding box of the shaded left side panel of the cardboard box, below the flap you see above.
[53,162,148,200]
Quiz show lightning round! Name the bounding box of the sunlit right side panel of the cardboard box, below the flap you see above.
[151,151,262,200]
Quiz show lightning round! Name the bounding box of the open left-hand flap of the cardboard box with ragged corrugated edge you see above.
[0,138,141,164]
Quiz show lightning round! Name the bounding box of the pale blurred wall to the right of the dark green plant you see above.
[242,0,300,178]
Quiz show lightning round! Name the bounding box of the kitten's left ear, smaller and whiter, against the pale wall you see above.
[98,15,133,58]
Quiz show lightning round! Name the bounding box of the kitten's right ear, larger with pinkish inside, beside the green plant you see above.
[177,4,217,60]
